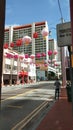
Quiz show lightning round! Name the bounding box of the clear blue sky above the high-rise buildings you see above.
[5,0,70,38]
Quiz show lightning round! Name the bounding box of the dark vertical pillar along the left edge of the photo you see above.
[0,0,6,110]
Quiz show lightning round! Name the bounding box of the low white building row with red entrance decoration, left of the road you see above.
[2,48,36,85]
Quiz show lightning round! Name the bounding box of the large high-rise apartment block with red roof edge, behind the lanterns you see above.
[4,21,48,60]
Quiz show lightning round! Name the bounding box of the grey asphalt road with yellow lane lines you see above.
[0,83,54,130]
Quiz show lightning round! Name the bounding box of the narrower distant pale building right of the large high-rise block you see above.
[48,38,61,77]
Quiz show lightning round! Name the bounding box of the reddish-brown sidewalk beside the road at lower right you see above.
[36,88,73,130]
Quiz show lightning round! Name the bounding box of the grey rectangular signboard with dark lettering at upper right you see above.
[56,22,72,47]
